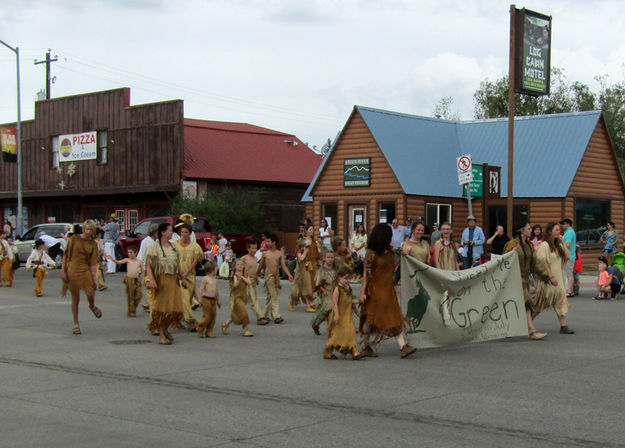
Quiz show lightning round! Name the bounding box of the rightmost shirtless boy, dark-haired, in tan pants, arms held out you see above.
[256,234,293,324]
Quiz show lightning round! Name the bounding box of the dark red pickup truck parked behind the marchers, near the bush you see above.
[119,216,254,257]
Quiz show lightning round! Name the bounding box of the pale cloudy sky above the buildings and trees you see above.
[0,0,625,147]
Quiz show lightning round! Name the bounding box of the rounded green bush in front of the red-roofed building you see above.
[171,187,264,233]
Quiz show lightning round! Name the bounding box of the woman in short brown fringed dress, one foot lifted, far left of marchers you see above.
[61,220,102,334]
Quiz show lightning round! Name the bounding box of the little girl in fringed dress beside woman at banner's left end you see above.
[323,266,365,361]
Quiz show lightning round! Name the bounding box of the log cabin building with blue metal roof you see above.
[302,106,625,265]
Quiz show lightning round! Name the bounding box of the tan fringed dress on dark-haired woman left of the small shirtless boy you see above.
[146,241,182,332]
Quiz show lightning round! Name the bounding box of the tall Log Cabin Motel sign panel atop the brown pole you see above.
[514,9,551,96]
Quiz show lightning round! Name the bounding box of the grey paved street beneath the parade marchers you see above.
[0,268,625,448]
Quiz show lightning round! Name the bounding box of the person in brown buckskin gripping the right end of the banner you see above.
[503,224,547,340]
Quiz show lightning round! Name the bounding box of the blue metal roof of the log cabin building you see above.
[354,106,601,197]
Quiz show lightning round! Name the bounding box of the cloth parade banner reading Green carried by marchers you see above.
[401,251,527,348]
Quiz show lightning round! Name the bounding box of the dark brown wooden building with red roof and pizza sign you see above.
[0,88,322,232]
